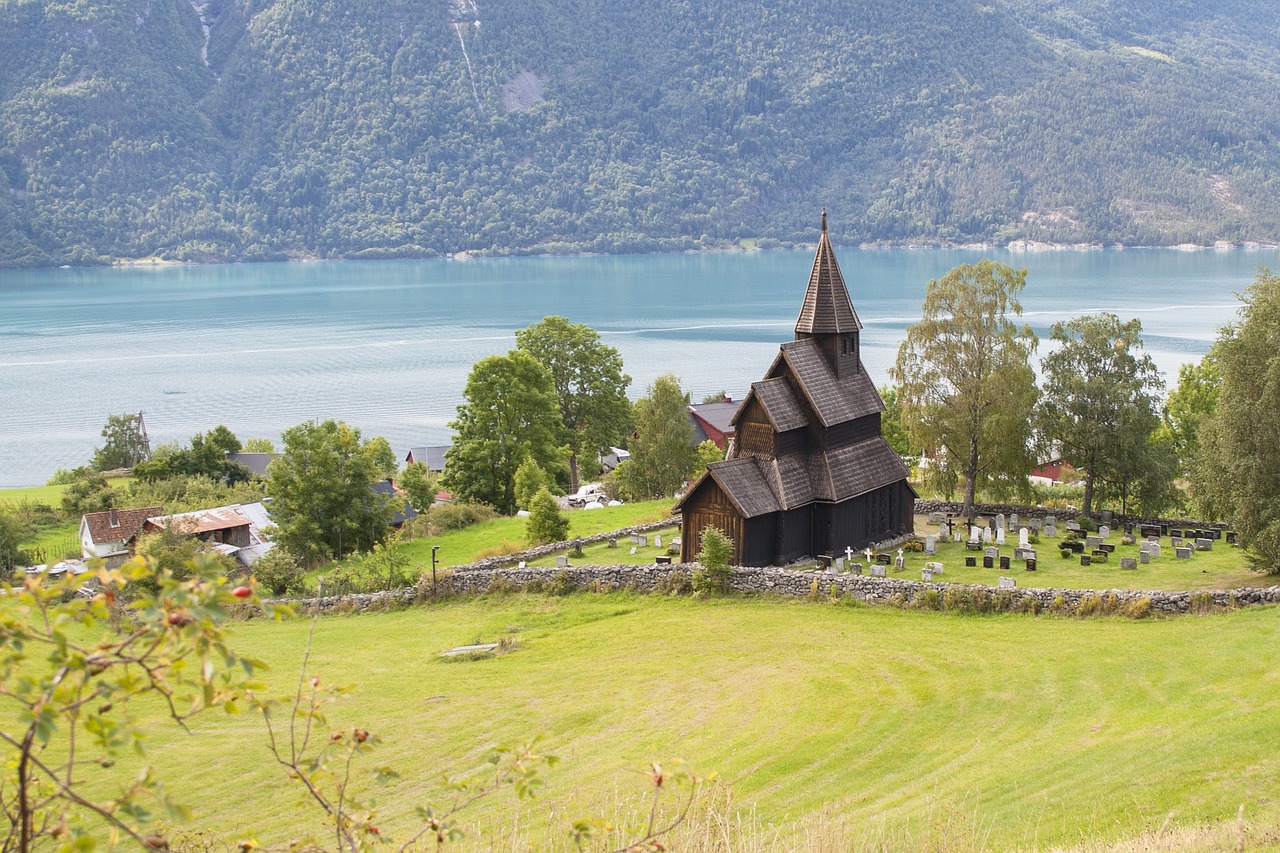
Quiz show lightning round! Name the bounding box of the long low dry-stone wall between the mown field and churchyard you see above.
[272,564,1280,615]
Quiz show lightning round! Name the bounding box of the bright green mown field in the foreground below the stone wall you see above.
[77,593,1280,850]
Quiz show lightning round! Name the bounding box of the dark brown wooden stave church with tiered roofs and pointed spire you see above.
[676,213,915,566]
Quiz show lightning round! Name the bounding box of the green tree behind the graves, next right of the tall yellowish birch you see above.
[1038,314,1172,512]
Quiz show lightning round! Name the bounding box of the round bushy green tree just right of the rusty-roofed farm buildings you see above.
[268,420,392,565]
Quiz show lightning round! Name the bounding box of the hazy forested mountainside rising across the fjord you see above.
[0,0,1280,265]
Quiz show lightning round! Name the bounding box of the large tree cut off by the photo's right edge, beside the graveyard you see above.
[1192,269,1280,574]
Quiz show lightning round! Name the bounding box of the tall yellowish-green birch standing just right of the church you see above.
[890,260,1038,517]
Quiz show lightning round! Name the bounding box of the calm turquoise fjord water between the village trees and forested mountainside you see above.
[0,248,1275,487]
